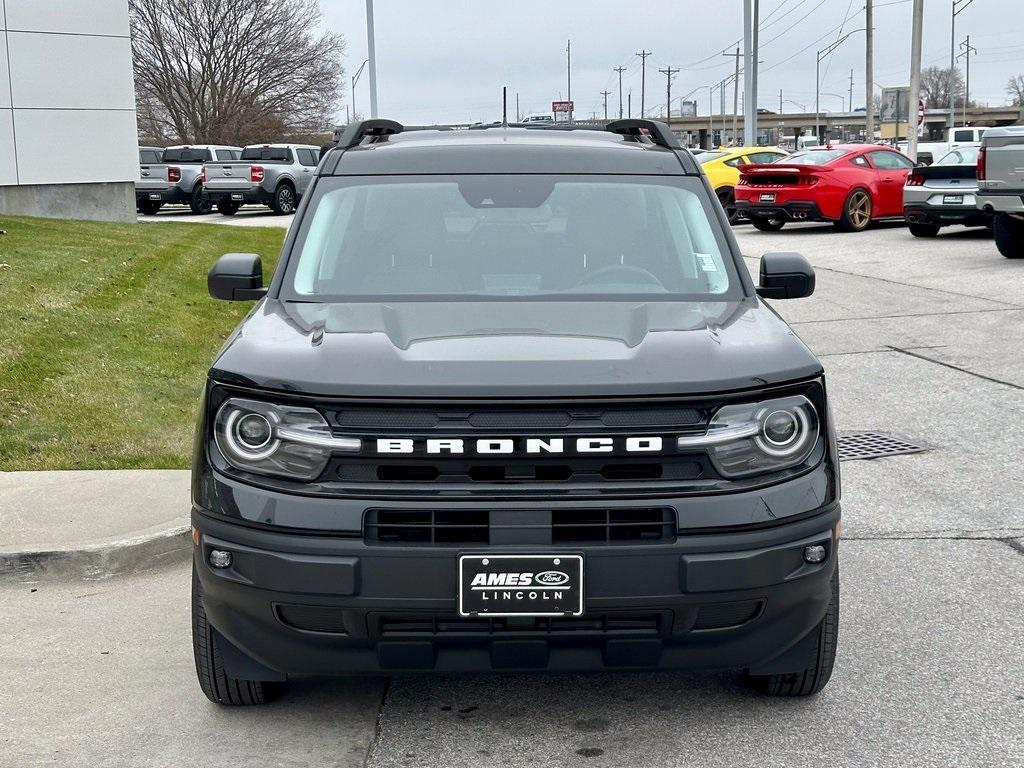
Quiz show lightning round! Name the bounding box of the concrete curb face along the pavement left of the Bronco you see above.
[0,525,191,581]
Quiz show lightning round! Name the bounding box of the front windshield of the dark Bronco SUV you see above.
[283,175,740,301]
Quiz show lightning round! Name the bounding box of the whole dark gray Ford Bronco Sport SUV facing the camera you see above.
[191,120,840,705]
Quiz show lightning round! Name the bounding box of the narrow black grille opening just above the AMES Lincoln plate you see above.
[364,507,676,546]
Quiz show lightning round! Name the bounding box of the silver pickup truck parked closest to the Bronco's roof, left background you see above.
[203,144,321,216]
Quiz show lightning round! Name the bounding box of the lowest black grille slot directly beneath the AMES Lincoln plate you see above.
[376,611,671,639]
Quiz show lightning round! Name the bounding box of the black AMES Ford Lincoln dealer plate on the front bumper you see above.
[459,555,583,616]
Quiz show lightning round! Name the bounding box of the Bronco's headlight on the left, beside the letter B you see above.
[213,398,361,480]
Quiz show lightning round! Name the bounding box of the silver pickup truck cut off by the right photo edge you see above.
[977,125,1024,259]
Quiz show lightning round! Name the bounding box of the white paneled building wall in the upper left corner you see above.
[0,0,138,199]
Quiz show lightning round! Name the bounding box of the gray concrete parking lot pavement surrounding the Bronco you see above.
[0,219,1024,768]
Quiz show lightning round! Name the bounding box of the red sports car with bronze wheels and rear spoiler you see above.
[736,144,913,231]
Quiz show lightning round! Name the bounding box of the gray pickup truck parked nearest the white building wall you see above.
[135,144,242,216]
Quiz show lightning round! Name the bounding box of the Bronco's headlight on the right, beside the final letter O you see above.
[677,395,818,477]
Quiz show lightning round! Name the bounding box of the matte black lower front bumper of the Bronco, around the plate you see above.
[193,503,840,679]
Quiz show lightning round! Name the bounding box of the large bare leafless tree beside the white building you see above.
[129,0,345,144]
